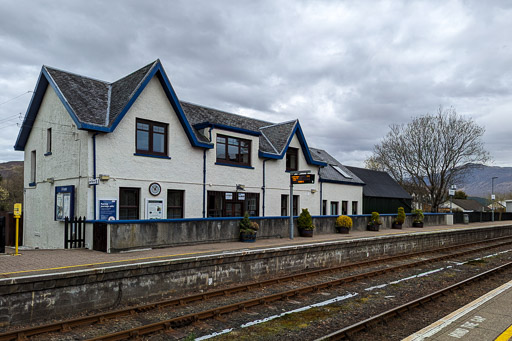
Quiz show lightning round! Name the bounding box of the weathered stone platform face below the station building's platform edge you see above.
[0,225,512,325]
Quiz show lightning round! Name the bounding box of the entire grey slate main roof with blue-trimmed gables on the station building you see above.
[14,60,326,166]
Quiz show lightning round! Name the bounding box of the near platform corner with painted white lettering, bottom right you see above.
[404,281,512,341]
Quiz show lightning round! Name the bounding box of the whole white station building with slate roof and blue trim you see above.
[15,60,364,248]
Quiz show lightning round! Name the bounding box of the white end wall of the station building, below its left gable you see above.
[23,86,91,248]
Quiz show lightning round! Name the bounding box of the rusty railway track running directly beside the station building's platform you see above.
[0,237,512,341]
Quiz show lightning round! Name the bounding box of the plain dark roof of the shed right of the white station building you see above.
[346,167,412,199]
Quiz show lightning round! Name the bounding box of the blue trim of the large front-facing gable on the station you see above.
[108,61,213,149]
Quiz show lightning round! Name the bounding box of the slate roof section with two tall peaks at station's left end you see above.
[14,60,213,150]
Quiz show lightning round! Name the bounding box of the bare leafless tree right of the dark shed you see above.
[366,108,489,212]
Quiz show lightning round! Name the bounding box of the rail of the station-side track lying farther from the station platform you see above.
[84,238,509,341]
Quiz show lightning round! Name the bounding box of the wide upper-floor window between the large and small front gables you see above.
[217,135,251,166]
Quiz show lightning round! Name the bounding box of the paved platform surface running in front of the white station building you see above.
[0,222,504,279]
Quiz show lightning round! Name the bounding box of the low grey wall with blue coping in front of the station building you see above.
[107,213,450,252]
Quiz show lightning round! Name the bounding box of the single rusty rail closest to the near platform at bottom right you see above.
[315,262,512,341]
